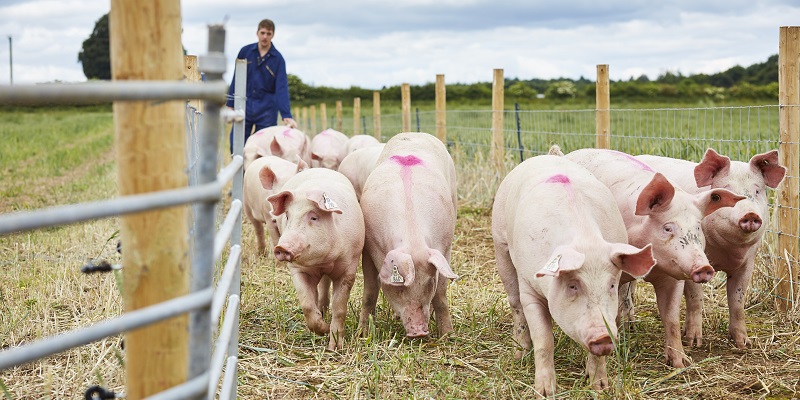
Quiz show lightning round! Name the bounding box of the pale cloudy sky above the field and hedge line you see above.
[0,0,800,89]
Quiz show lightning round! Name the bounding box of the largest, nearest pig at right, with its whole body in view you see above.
[492,155,656,397]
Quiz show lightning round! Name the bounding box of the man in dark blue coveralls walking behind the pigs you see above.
[226,19,297,153]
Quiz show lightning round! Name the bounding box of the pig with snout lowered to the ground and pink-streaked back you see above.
[358,132,458,338]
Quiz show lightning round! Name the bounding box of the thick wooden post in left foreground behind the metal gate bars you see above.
[109,0,191,399]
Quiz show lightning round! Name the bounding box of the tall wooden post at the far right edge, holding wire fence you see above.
[775,26,800,311]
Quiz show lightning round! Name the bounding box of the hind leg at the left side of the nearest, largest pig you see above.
[495,242,531,360]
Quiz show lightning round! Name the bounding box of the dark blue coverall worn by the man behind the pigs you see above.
[226,43,292,127]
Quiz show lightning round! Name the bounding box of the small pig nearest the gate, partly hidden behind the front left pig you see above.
[242,155,308,254]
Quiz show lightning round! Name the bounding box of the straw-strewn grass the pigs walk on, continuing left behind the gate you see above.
[0,104,800,399]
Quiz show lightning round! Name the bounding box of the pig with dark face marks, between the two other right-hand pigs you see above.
[565,149,744,368]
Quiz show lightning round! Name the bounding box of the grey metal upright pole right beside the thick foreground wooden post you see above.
[189,25,225,398]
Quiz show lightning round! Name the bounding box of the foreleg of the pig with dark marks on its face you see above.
[651,272,689,368]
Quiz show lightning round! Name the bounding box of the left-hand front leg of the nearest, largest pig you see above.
[521,295,556,397]
